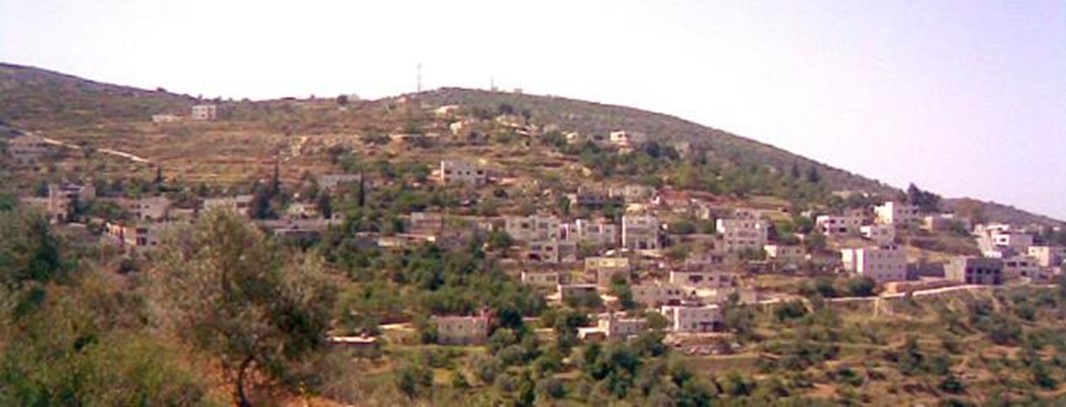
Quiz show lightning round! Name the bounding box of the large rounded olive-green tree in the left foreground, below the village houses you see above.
[151,211,333,406]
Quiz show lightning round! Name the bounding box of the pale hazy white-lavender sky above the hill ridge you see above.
[6,0,1066,218]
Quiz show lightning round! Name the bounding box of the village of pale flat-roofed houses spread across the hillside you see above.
[5,98,1066,352]
